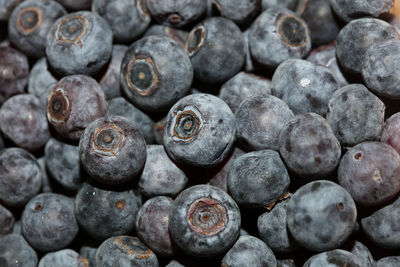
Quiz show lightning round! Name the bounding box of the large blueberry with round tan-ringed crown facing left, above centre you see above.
[120,36,193,111]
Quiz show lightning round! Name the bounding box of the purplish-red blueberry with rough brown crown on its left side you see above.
[47,75,107,140]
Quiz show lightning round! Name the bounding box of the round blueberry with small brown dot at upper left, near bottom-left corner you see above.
[22,193,79,252]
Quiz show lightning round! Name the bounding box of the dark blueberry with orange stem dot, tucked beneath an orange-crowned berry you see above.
[75,184,142,240]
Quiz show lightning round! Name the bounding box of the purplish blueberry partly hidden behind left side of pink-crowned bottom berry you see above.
[136,196,178,257]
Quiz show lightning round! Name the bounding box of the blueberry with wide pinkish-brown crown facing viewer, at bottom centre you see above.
[169,185,241,257]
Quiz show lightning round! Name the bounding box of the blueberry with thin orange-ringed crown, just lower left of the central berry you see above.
[79,116,146,184]
